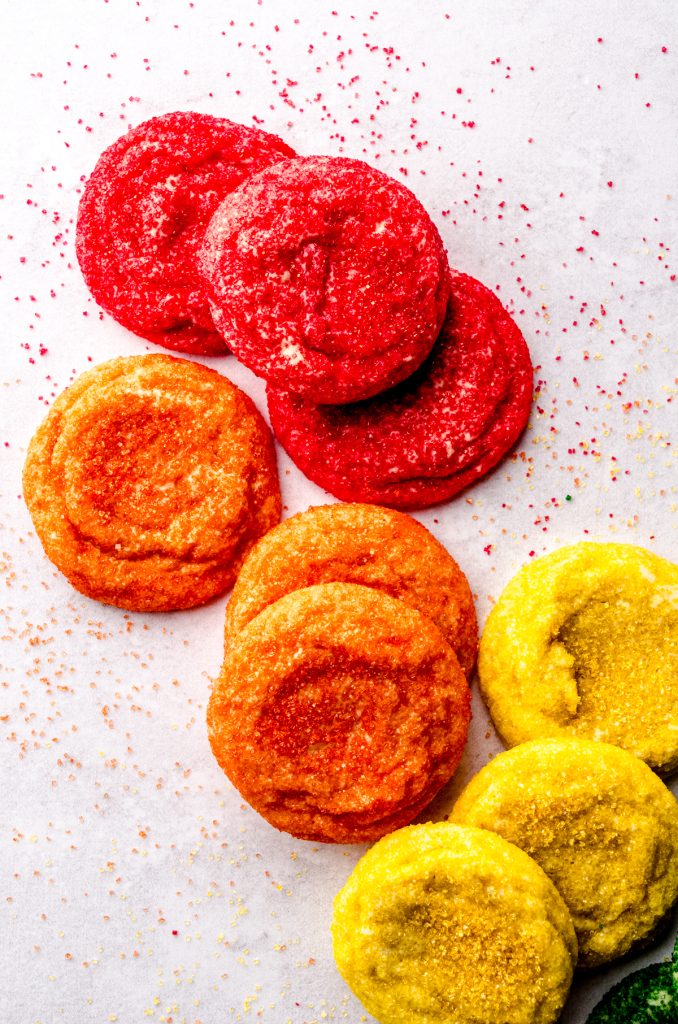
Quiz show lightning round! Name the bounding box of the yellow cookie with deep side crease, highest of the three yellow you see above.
[478,542,678,772]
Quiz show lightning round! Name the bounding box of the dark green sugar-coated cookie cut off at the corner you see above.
[587,964,678,1024]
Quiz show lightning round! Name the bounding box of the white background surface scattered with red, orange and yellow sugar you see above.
[0,0,678,1024]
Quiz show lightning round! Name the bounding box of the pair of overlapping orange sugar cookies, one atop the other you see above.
[208,504,477,843]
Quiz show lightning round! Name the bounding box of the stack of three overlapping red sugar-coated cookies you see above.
[77,113,532,509]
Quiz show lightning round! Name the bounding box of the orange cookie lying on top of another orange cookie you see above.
[207,583,470,843]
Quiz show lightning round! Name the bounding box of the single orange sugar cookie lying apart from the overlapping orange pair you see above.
[24,355,281,611]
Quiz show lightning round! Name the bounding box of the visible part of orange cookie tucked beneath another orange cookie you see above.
[226,504,477,676]
